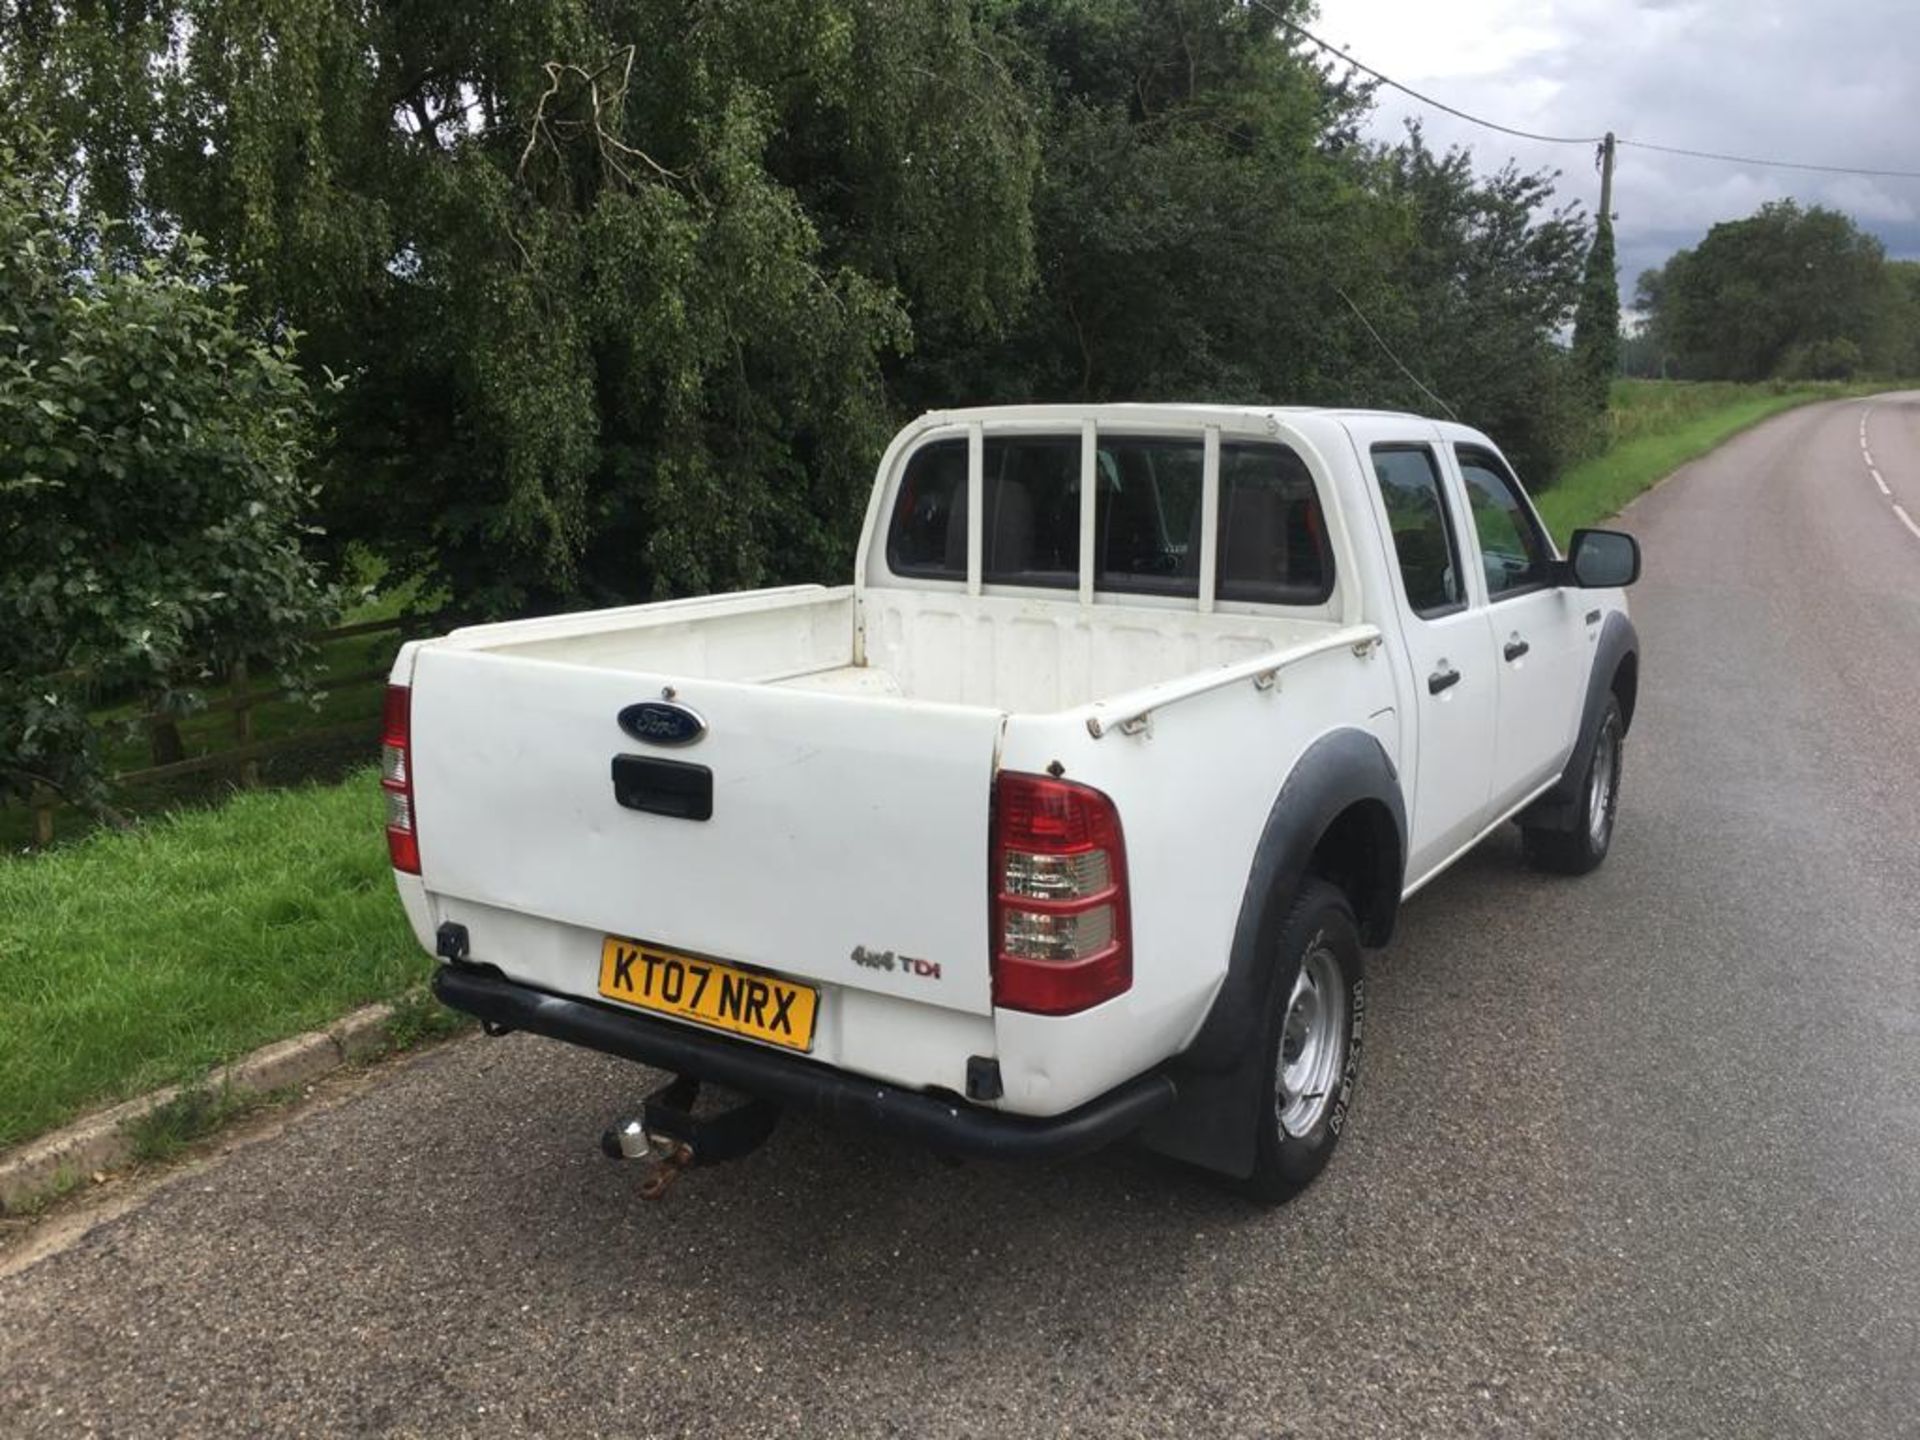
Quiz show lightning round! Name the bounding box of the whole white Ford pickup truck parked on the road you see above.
[382,405,1640,1198]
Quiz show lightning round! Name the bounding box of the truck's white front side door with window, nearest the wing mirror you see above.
[1452,444,1586,814]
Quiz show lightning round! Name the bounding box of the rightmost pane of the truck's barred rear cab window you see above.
[1213,440,1332,605]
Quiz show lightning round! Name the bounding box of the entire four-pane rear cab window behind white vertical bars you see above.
[887,430,1334,605]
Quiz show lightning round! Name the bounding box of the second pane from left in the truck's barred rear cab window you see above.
[990,436,1079,589]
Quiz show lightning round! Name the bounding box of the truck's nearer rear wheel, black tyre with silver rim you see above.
[1246,879,1367,1202]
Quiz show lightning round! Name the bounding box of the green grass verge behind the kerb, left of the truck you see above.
[0,772,430,1146]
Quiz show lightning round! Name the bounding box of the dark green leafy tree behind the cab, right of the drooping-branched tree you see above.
[925,0,1386,405]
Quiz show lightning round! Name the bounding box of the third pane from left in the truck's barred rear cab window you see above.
[1092,436,1206,597]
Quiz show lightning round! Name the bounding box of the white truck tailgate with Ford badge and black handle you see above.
[411,645,1002,1014]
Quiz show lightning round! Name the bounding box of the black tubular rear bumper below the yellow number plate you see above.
[434,966,1173,1160]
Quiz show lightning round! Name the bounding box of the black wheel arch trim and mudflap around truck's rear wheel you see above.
[1140,728,1407,1177]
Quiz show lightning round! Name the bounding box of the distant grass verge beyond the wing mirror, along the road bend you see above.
[1534,380,1895,545]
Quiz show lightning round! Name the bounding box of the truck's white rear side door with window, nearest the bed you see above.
[1354,424,1498,883]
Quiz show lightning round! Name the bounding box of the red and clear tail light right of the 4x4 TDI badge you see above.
[993,772,1133,1016]
